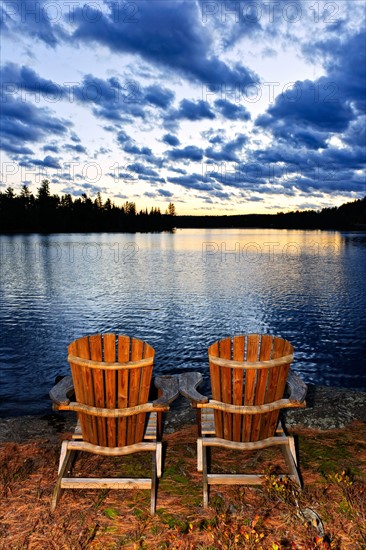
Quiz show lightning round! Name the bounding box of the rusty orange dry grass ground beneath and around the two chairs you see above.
[0,423,366,550]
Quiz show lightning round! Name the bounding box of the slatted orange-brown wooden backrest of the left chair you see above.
[68,334,155,447]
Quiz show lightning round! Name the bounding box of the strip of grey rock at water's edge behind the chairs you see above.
[0,385,366,443]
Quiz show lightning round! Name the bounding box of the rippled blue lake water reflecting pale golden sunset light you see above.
[0,229,366,416]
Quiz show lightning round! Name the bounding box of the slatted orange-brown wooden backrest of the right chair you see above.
[208,334,293,442]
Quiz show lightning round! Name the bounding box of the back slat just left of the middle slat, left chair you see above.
[87,334,108,446]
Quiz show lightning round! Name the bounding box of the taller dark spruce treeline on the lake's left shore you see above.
[0,180,175,233]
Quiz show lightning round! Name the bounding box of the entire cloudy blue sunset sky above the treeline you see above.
[0,0,366,215]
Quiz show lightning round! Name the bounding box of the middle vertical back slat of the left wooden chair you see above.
[103,334,118,447]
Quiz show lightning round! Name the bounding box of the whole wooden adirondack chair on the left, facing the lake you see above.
[50,334,179,514]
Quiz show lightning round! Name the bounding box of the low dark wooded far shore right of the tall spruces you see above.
[175,197,366,230]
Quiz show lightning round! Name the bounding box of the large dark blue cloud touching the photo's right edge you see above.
[257,31,366,144]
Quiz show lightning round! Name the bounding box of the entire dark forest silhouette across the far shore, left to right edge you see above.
[0,180,366,233]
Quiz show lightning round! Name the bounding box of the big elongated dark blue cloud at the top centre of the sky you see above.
[72,0,257,86]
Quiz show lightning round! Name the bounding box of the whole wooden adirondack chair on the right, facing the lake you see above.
[186,334,307,506]
